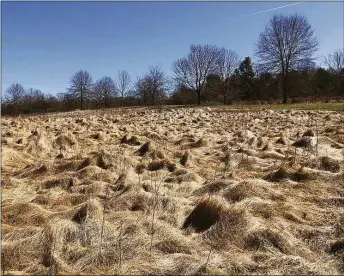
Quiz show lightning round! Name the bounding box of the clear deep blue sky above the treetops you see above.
[1,2,344,94]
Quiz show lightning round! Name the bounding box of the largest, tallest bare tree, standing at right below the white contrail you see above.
[255,14,318,103]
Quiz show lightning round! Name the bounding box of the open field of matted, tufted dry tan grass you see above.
[1,104,344,275]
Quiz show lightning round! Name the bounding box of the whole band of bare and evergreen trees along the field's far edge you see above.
[2,14,344,114]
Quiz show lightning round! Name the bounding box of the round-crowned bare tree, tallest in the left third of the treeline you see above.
[67,70,93,109]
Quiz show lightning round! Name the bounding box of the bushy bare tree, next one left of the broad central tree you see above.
[136,66,169,105]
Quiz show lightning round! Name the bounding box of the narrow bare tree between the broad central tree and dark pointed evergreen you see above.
[218,48,239,105]
